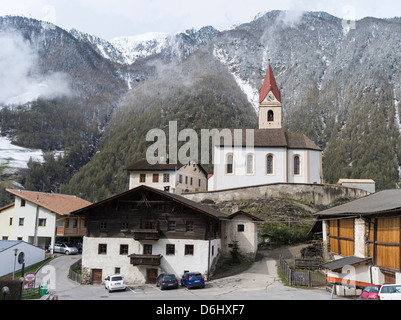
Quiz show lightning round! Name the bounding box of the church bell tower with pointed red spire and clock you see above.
[259,59,282,129]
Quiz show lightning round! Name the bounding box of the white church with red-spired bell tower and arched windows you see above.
[208,62,323,191]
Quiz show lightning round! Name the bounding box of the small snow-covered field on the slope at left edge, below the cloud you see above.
[0,137,43,169]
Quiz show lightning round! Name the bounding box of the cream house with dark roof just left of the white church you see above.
[127,158,208,194]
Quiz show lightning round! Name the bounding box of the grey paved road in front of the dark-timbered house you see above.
[37,251,330,300]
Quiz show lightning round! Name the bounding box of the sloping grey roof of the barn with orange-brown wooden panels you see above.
[315,189,401,218]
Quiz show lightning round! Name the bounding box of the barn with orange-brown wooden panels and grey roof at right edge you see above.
[316,189,401,294]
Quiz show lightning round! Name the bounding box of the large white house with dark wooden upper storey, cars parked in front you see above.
[73,186,260,284]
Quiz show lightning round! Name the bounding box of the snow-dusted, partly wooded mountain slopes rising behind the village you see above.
[0,11,401,201]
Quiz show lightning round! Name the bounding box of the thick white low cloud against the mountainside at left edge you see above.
[0,32,71,105]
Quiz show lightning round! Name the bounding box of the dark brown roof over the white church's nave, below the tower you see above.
[214,129,322,151]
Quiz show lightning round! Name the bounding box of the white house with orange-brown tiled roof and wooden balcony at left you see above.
[0,189,91,249]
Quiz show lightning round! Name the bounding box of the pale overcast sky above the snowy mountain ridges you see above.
[0,0,401,40]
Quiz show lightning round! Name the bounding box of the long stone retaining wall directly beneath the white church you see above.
[182,183,370,206]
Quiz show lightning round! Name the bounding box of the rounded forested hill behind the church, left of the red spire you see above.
[61,51,256,201]
